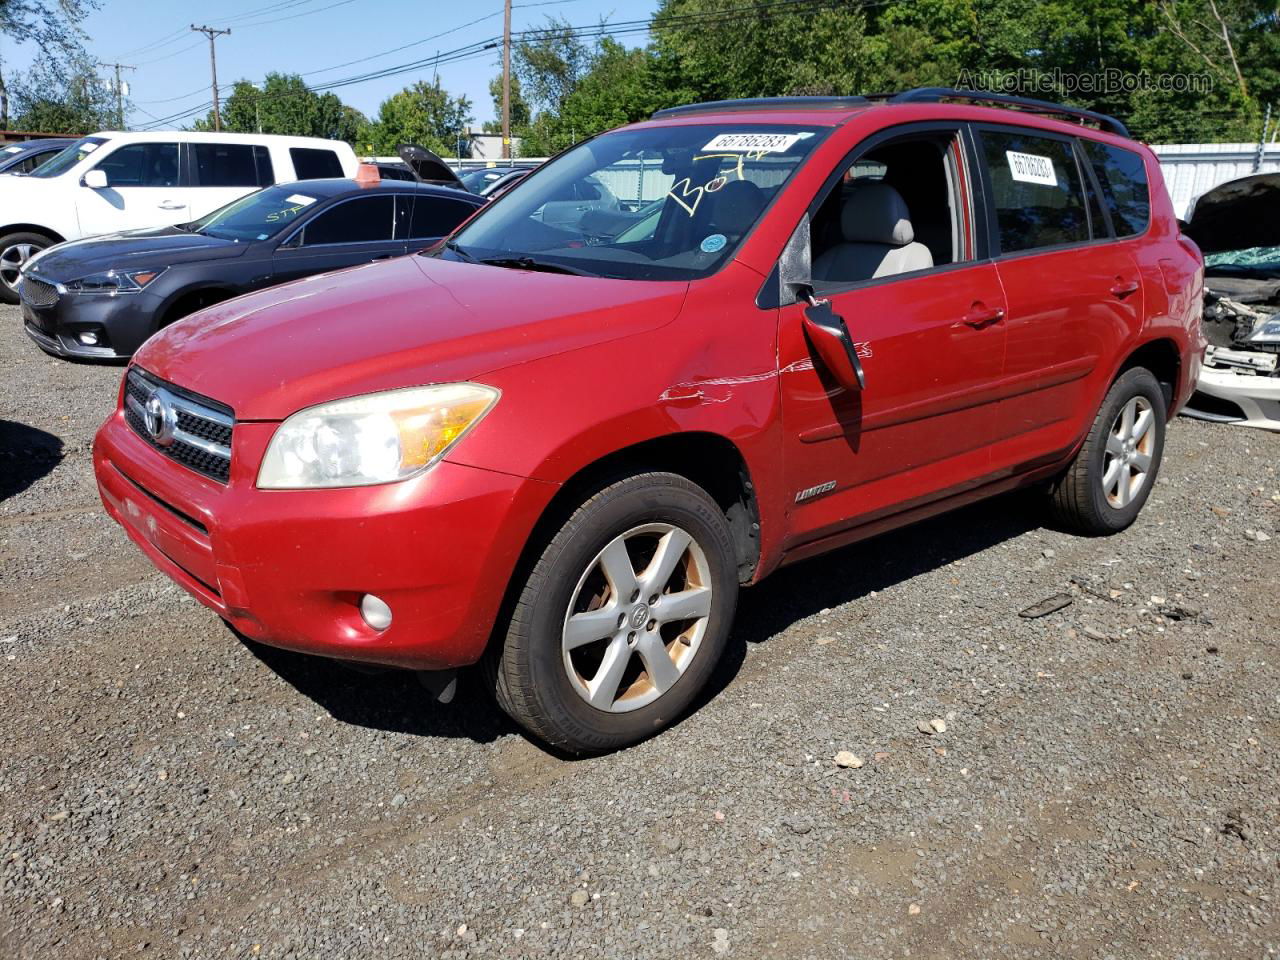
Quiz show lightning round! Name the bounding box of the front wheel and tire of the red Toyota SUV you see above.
[489,472,737,754]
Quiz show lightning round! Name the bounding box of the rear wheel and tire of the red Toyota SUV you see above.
[1051,367,1167,536]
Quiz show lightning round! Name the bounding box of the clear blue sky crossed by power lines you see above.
[0,0,658,127]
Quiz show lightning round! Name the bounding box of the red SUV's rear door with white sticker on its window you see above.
[978,124,1143,472]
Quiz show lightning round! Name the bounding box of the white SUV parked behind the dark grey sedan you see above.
[0,131,356,303]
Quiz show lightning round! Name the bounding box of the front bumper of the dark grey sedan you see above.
[22,291,161,360]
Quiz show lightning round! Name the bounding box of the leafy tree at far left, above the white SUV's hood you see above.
[9,56,116,134]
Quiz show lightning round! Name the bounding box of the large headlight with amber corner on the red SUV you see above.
[257,383,498,490]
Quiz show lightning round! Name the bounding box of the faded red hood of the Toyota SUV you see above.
[134,256,687,420]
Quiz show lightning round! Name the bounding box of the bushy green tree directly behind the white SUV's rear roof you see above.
[195,73,369,143]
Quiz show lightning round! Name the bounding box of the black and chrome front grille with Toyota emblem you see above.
[124,366,236,484]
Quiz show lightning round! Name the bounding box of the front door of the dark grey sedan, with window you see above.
[271,191,406,283]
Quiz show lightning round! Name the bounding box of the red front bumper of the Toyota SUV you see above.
[93,411,556,669]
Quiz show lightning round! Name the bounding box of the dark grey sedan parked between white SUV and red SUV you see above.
[18,179,484,360]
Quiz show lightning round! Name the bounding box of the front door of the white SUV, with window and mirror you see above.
[76,140,191,237]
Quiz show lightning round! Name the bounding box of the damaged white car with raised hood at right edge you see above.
[1183,173,1280,431]
